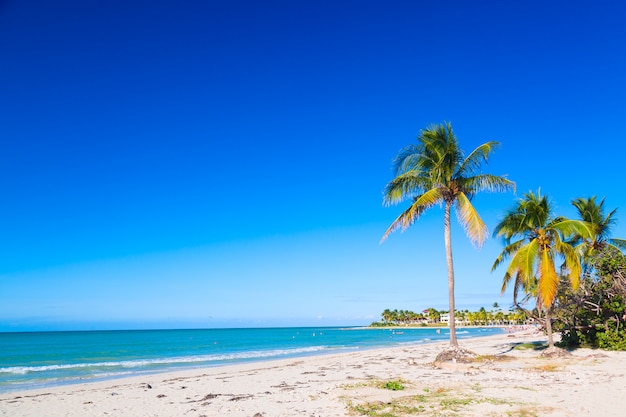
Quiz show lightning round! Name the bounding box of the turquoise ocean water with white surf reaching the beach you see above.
[0,327,503,392]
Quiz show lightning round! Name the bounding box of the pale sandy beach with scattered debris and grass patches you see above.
[0,331,626,417]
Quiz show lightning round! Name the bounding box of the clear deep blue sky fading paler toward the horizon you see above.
[0,0,626,331]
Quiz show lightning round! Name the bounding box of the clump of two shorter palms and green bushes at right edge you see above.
[492,192,626,349]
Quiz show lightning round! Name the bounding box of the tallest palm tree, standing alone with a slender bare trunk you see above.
[381,123,515,349]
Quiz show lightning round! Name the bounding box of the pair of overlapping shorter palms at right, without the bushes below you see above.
[492,192,626,348]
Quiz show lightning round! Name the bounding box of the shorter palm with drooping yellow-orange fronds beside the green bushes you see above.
[491,191,593,348]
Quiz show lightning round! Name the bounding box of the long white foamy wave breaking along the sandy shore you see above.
[0,346,327,375]
